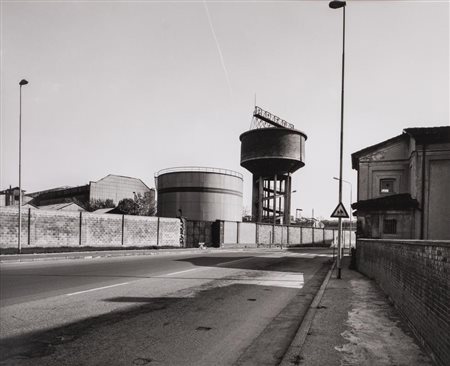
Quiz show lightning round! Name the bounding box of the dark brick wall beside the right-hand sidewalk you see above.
[356,239,450,365]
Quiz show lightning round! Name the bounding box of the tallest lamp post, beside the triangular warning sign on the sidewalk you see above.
[328,0,346,279]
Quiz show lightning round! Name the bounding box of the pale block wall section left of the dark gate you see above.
[0,208,180,249]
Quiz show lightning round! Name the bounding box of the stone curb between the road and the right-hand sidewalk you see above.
[279,261,336,366]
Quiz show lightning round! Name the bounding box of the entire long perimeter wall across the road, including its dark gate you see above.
[0,207,349,249]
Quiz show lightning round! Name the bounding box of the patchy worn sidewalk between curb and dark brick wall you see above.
[281,257,432,366]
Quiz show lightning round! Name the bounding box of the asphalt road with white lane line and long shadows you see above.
[0,250,330,366]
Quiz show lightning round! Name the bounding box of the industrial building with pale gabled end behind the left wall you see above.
[28,174,155,212]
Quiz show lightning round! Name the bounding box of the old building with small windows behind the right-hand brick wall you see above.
[352,126,450,240]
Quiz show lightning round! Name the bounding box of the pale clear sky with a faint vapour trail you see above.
[0,0,450,218]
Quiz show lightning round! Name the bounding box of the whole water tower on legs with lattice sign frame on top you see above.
[239,106,307,224]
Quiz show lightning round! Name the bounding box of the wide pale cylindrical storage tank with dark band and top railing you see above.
[155,167,243,221]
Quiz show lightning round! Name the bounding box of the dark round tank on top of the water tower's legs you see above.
[240,128,307,176]
